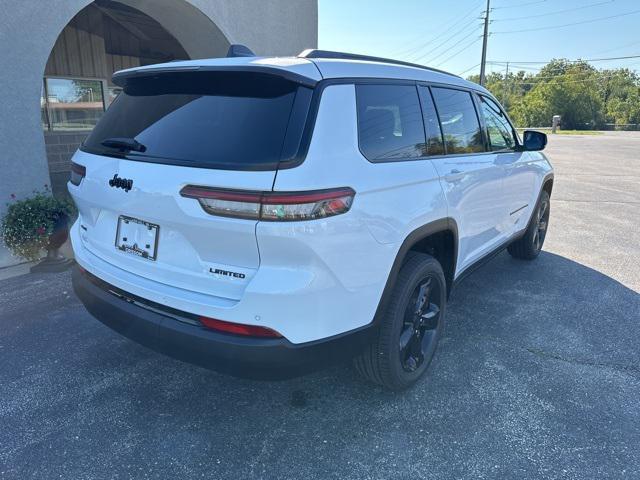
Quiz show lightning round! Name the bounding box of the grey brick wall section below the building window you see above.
[44,132,88,196]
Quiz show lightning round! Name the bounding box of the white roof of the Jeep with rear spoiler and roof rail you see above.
[113,50,486,91]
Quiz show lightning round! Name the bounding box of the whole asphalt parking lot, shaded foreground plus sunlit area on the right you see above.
[0,133,640,479]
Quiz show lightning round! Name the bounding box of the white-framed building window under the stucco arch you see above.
[41,77,105,131]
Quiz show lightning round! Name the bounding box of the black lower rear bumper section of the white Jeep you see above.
[73,267,375,380]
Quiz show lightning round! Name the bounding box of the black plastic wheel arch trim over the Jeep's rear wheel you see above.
[374,218,458,322]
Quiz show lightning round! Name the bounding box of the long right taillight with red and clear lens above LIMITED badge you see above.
[180,185,356,222]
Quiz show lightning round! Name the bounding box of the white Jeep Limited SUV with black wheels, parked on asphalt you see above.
[69,47,553,389]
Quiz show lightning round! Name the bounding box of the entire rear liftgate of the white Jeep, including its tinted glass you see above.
[69,67,311,300]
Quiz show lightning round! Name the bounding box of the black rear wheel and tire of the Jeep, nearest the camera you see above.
[354,252,447,390]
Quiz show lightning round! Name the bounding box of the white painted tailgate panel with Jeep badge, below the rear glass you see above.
[70,152,274,300]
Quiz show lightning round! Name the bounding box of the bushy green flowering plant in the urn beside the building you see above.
[0,185,76,261]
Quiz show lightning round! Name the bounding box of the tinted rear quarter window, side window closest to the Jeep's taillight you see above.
[356,85,426,162]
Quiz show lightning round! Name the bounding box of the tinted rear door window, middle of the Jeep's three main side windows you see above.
[431,88,484,154]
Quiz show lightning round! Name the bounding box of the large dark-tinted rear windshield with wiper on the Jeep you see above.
[82,72,312,170]
